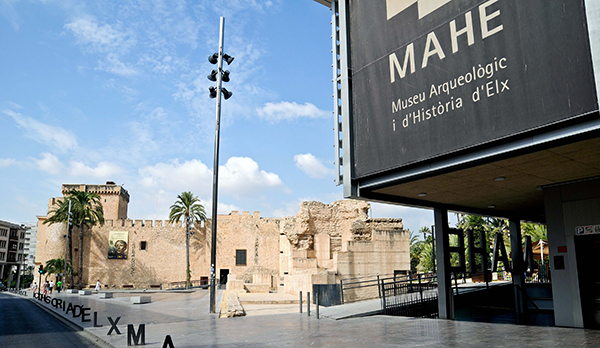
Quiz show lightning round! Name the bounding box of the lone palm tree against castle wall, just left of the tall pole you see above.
[169,191,206,289]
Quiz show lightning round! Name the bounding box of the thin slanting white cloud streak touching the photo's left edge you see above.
[2,110,77,151]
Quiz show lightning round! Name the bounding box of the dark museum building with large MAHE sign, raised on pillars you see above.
[315,0,600,329]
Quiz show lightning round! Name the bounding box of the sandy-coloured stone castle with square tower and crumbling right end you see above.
[36,182,410,294]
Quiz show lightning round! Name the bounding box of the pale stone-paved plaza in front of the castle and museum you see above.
[16,290,600,348]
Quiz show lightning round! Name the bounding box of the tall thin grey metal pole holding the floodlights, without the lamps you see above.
[210,17,225,313]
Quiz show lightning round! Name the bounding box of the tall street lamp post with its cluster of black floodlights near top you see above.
[208,17,233,313]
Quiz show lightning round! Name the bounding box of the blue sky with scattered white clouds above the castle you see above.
[0,0,433,235]
